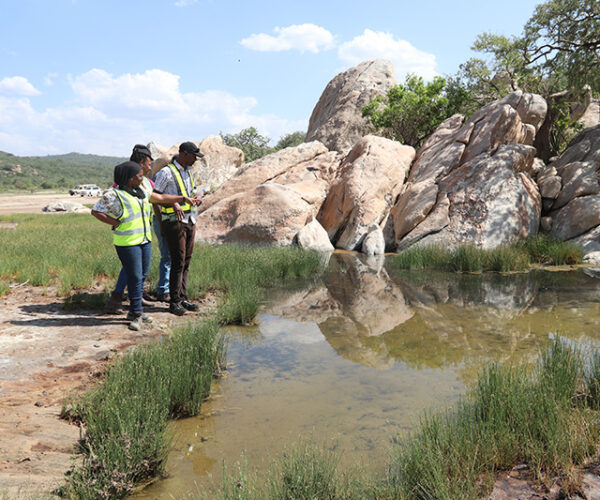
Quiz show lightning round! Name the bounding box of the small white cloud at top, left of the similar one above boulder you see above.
[240,24,335,53]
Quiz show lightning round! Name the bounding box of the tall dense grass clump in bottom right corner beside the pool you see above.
[388,338,600,499]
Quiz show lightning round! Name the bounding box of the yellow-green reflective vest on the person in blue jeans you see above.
[113,188,152,247]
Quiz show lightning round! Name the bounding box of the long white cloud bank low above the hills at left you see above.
[0,69,307,156]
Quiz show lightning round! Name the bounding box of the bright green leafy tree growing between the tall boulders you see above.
[362,75,466,148]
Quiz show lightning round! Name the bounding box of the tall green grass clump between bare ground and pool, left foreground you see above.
[61,322,224,499]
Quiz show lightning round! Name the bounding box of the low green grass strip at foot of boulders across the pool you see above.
[389,235,583,272]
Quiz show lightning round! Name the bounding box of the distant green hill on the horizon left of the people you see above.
[0,151,127,191]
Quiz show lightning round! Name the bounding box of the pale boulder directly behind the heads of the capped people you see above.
[148,135,244,191]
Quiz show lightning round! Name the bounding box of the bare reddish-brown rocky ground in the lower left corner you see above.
[0,285,215,498]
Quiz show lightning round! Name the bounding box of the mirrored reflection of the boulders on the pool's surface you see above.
[269,254,600,376]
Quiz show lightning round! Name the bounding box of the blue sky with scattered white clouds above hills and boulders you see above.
[0,0,539,156]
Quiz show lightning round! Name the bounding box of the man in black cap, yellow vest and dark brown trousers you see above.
[154,142,204,316]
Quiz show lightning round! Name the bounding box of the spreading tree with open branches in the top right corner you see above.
[450,0,600,160]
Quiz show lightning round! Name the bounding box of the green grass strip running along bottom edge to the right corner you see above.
[205,338,600,500]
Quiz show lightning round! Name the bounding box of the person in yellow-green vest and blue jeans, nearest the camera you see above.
[92,161,197,330]
